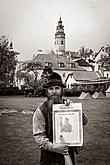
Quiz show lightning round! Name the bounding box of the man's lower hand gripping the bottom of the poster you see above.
[51,144,68,154]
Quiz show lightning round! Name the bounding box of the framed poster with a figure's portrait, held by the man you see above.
[53,103,83,146]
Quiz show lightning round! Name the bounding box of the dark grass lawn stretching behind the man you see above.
[0,96,110,165]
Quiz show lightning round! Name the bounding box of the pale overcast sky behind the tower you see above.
[0,0,110,60]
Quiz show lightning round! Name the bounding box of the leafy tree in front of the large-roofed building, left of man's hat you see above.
[17,62,53,96]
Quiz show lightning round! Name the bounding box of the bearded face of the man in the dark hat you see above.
[47,85,62,103]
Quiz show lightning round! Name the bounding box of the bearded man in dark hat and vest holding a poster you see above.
[33,72,87,165]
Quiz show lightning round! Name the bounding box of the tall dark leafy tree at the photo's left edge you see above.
[0,35,19,86]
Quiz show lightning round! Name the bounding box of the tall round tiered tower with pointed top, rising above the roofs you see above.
[55,17,65,55]
